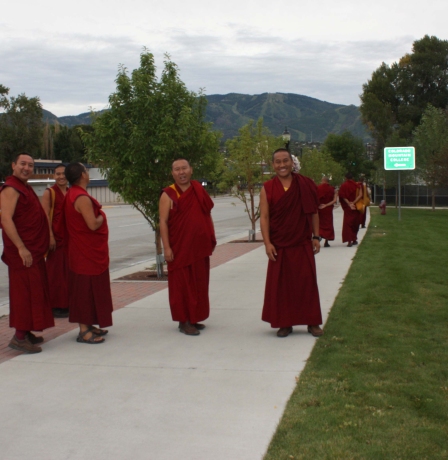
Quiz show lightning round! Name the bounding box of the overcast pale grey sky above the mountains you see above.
[0,0,448,116]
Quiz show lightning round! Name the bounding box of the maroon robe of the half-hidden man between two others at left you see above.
[47,184,68,308]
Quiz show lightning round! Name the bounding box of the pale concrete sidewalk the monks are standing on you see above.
[0,209,365,460]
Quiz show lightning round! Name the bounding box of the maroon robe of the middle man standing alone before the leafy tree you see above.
[163,180,216,324]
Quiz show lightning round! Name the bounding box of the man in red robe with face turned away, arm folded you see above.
[61,163,113,345]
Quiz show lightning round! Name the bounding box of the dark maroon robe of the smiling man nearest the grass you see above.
[262,173,322,328]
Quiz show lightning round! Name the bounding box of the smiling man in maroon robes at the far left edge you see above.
[1,153,54,353]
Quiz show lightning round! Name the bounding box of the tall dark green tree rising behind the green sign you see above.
[360,35,448,158]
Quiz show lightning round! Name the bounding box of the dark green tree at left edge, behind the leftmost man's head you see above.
[0,85,43,180]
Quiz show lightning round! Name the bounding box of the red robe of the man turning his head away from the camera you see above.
[60,185,113,327]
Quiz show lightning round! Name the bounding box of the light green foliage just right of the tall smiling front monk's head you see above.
[300,149,346,184]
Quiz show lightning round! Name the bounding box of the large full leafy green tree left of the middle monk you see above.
[82,49,219,274]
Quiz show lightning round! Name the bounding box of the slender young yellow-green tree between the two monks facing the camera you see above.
[222,118,283,241]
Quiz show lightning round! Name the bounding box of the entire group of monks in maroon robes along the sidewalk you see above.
[0,148,372,353]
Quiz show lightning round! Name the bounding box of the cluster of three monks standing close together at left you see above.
[0,153,112,353]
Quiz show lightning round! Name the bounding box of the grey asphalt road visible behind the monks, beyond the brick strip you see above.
[0,196,260,305]
